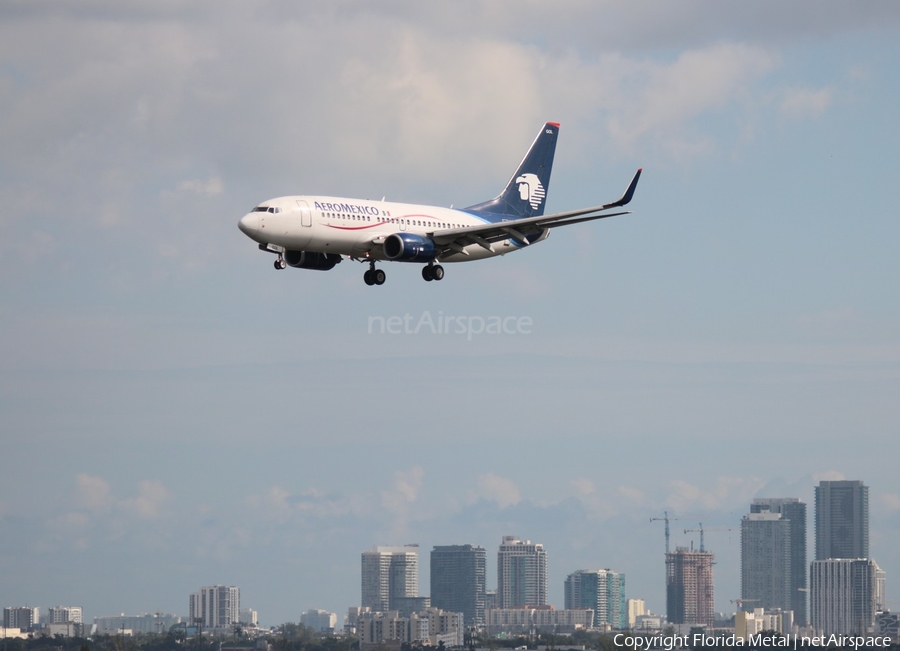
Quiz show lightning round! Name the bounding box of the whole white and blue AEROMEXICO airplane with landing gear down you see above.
[238,122,641,285]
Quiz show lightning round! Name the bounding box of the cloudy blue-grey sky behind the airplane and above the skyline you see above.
[0,0,900,626]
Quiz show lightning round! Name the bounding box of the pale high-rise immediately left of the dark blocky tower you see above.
[361,545,419,612]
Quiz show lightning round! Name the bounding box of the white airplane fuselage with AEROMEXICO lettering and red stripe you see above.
[240,196,544,262]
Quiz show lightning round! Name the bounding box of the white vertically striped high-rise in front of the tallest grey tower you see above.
[809,558,884,635]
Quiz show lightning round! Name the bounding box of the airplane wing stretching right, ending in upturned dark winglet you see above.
[428,170,641,253]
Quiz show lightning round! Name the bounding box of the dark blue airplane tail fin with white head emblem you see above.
[464,122,559,218]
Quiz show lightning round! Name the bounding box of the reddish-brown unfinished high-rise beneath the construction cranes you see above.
[666,547,715,626]
